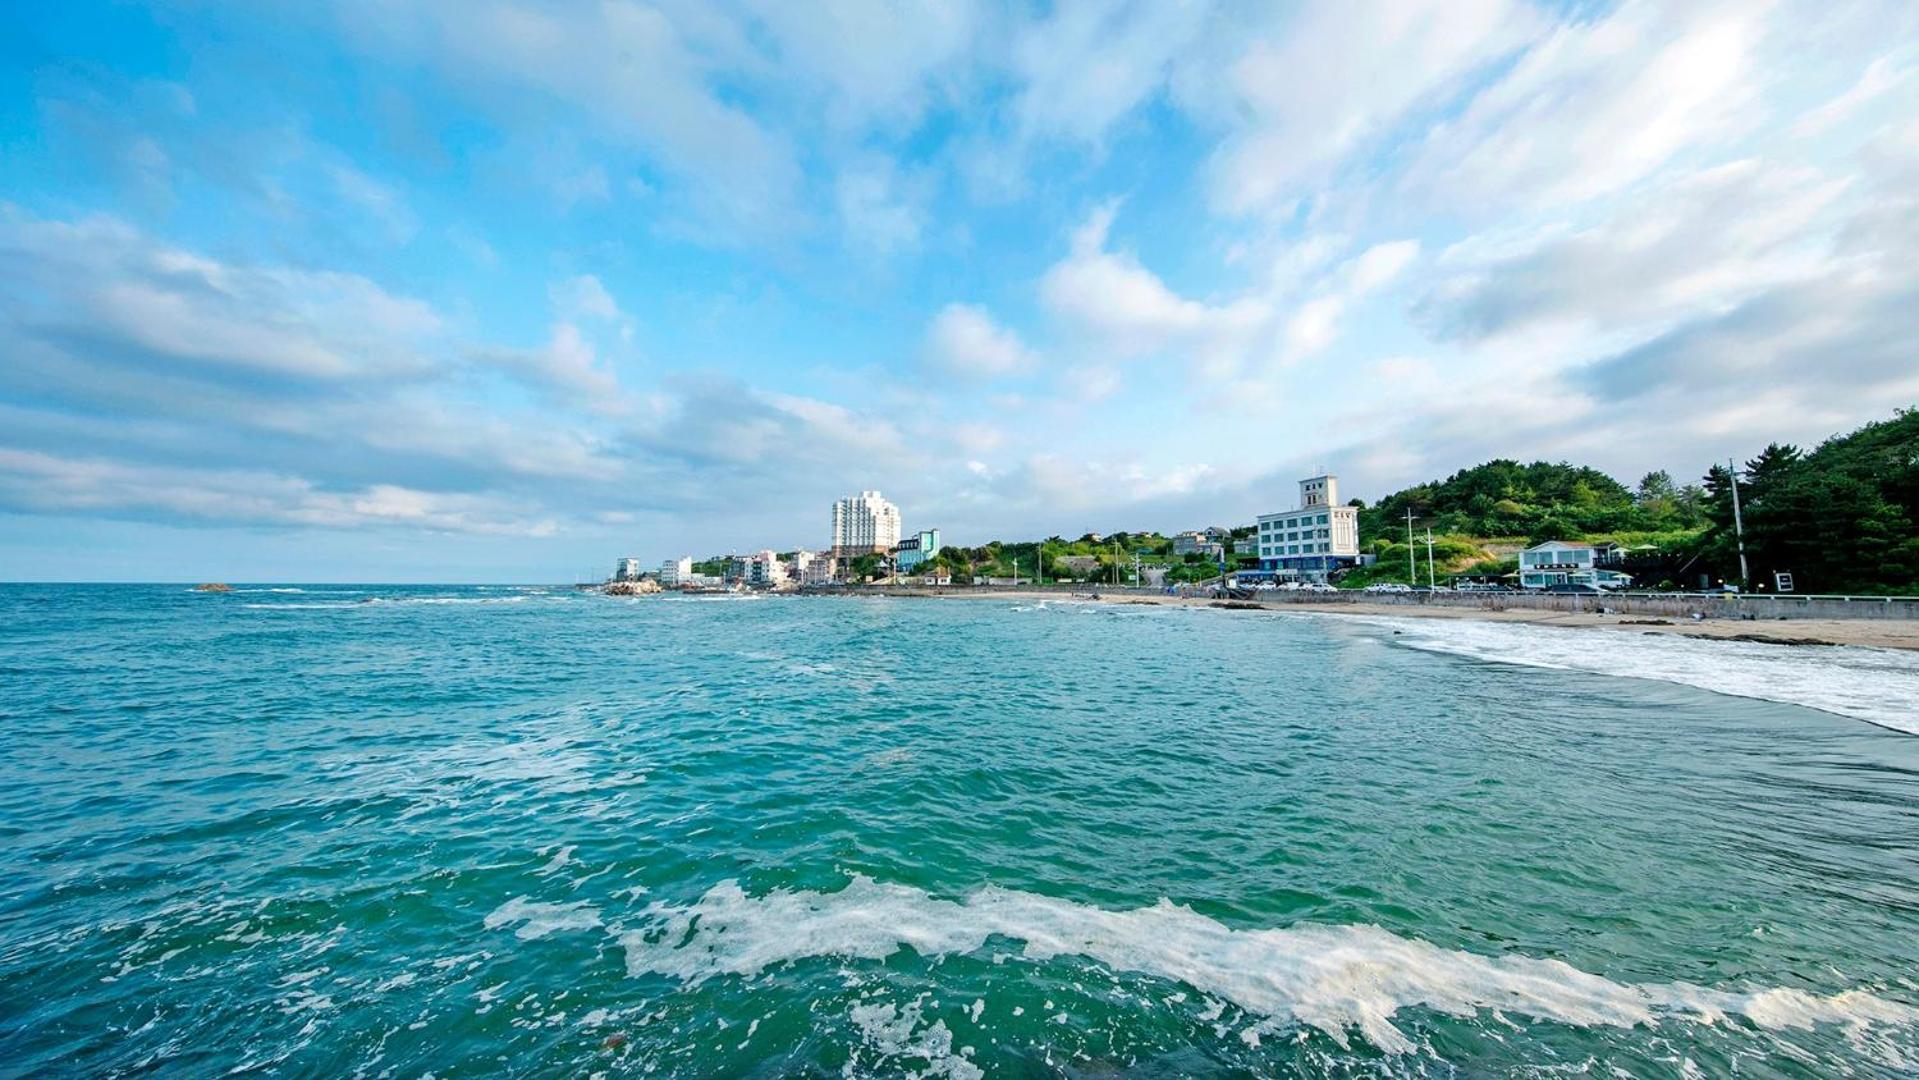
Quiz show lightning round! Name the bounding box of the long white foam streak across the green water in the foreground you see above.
[620,877,1919,1053]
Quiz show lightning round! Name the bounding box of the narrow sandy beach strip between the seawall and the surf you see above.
[844,587,1919,652]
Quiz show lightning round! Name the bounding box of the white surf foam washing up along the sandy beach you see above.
[1307,616,1919,735]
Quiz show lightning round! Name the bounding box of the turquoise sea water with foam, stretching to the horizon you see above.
[0,585,1919,1076]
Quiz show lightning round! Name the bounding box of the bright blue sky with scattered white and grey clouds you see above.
[0,0,1919,581]
